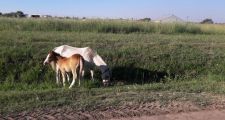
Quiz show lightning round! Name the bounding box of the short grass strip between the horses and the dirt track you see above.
[0,79,225,114]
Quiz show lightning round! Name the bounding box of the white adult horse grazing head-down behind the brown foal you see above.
[44,45,111,85]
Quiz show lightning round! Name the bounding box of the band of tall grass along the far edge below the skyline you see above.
[0,18,225,34]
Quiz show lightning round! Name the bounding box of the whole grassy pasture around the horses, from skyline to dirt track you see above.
[0,18,225,118]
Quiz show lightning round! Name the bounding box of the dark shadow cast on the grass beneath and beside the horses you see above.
[51,66,173,88]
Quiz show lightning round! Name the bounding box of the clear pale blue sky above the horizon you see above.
[0,0,225,22]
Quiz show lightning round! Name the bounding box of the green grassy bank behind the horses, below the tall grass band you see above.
[0,31,225,84]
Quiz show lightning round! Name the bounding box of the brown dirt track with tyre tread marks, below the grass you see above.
[3,101,225,120]
